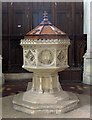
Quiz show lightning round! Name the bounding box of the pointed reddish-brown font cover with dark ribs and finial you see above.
[25,11,66,39]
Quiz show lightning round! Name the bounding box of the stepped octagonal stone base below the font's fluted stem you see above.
[13,91,79,115]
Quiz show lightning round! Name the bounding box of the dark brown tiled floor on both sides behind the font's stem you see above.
[0,80,92,97]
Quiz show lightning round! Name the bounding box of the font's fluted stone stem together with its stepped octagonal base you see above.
[13,73,79,114]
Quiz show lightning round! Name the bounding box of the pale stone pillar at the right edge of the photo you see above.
[83,0,92,85]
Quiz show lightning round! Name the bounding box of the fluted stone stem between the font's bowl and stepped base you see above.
[32,72,61,93]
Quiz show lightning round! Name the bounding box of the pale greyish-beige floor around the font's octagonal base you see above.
[0,93,92,117]
